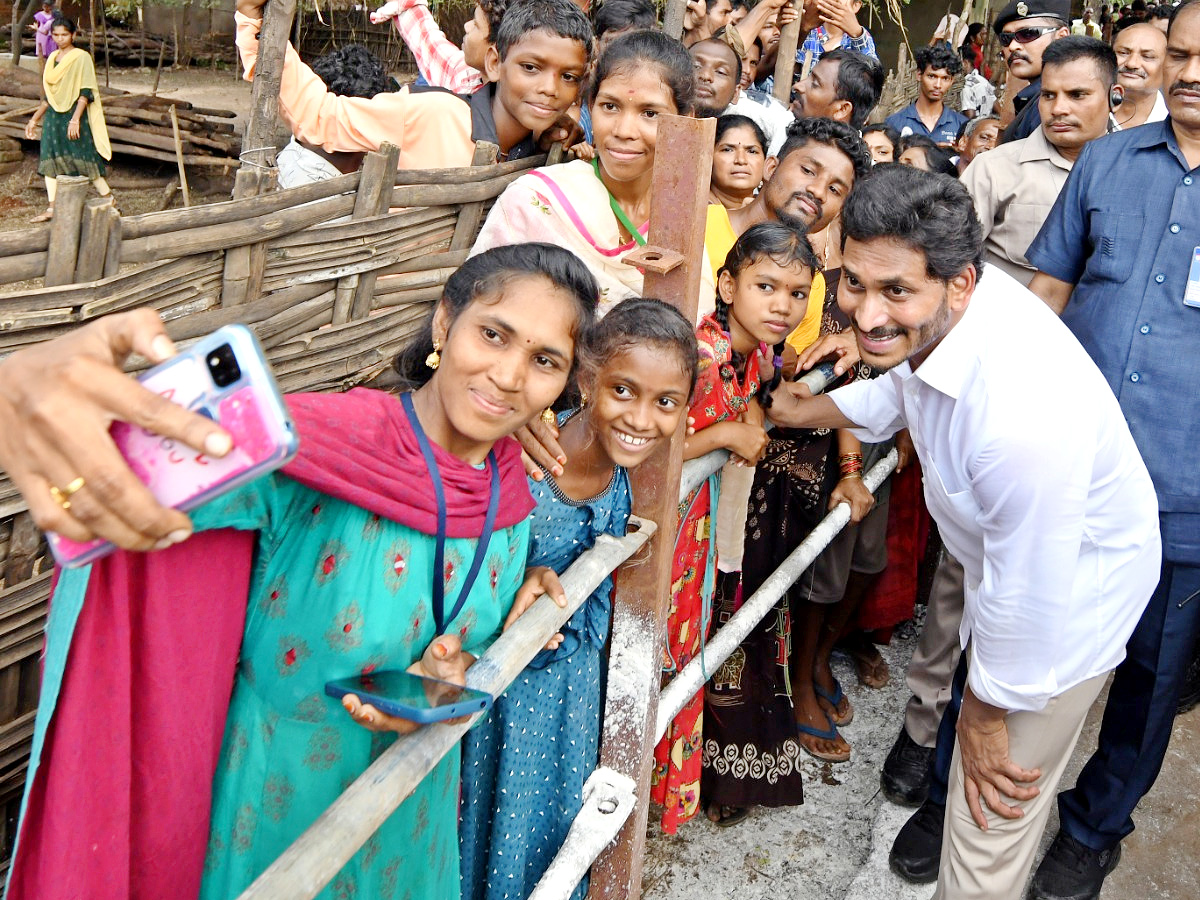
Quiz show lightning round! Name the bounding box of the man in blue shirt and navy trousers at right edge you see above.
[1027,0,1200,900]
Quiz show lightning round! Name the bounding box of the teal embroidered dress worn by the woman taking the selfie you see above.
[193,475,529,900]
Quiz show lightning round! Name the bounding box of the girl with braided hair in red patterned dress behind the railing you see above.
[650,223,817,834]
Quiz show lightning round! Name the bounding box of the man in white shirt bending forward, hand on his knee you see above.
[770,166,1160,900]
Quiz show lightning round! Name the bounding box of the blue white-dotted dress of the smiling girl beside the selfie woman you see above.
[461,460,630,900]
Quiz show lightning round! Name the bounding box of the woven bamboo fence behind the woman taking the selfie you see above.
[0,144,546,872]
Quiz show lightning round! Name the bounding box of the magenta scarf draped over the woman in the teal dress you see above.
[8,390,534,900]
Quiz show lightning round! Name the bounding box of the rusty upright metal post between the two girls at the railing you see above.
[589,115,716,900]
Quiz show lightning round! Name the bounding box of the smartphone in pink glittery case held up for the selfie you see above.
[47,325,296,568]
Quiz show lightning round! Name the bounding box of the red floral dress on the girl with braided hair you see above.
[650,316,767,834]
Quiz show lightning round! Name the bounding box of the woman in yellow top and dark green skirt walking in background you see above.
[25,17,113,222]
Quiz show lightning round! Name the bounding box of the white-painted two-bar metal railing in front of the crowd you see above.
[239,364,896,900]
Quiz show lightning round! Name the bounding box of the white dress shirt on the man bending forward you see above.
[829,266,1162,710]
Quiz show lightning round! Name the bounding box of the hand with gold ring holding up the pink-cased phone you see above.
[0,310,232,550]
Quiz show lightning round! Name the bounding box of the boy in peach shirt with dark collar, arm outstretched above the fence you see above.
[235,0,592,169]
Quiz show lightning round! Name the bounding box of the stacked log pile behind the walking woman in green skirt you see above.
[0,67,241,167]
